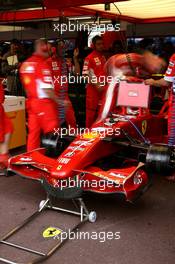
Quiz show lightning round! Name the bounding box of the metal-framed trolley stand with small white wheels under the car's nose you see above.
[0,182,96,264]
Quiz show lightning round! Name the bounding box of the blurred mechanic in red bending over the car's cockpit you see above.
[97,51,165,121]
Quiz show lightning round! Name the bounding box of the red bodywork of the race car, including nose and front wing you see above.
[9,81,166,200]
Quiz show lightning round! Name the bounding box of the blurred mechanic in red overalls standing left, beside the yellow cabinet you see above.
[20,39,59,151]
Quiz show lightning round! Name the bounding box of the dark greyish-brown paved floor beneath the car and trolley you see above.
[0,168,175,264]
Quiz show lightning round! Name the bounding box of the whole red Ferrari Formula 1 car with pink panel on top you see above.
[8,82,174,201]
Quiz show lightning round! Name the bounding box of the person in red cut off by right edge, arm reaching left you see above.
[145,54,175,181]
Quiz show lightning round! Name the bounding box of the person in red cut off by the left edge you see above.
[0,81,13,175]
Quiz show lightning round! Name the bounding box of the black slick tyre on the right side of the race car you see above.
[146,144,173,175]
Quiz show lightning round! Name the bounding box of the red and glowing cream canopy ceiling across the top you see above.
[0,0,175,23]
